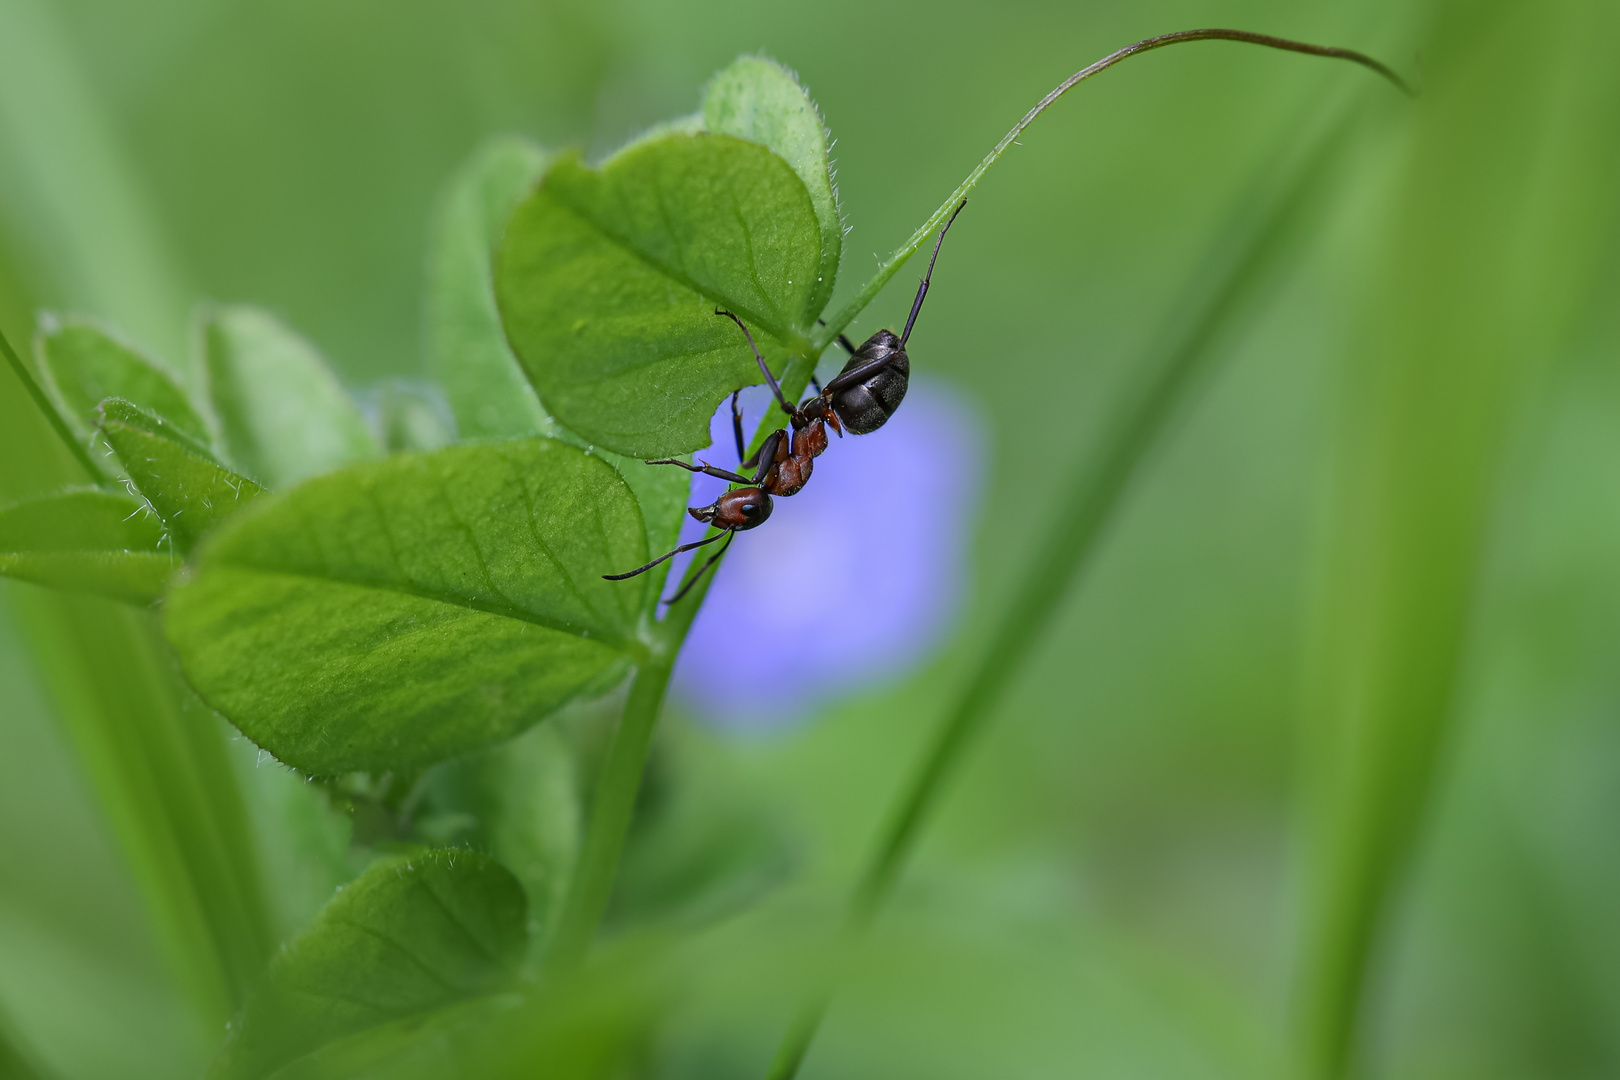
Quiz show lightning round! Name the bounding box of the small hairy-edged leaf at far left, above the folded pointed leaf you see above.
[34,316,209,442]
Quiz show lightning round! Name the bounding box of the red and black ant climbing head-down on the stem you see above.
[603,199,967,604]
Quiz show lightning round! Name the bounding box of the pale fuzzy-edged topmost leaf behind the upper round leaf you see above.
[703,57,844,311]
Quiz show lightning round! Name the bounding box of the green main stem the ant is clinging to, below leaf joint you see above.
[548,355,815,970]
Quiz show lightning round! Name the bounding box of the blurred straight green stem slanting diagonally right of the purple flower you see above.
[766,82,1373,1080]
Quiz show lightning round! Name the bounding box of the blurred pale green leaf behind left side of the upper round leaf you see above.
[426,138,546,439]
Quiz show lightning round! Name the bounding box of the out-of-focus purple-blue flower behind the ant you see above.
[669,379,982,730]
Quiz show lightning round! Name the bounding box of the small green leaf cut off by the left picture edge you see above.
[0,489,175,604]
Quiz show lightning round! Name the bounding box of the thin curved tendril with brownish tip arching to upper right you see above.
[812,29,1413,350]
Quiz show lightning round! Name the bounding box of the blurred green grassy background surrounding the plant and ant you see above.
[0,0,1620,1077]
